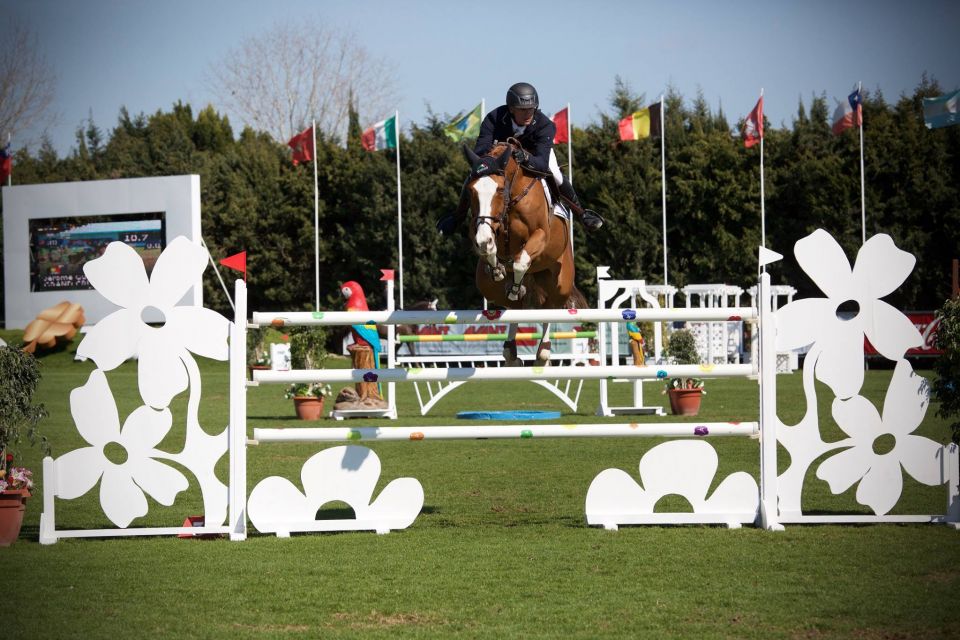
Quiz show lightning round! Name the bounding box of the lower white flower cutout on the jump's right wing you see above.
[817,360,946,515]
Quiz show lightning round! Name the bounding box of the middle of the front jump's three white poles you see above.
[253,364,757,384]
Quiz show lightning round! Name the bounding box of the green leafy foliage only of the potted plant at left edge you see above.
[0,345,50,467]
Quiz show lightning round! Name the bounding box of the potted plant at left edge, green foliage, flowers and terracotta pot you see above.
[0,346,50,546]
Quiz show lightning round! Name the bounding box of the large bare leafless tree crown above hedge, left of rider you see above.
[210,20,397,142]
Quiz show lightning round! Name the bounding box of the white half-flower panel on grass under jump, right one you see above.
[586,440,760,526]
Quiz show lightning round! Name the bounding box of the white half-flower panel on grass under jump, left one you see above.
[247,445,423,535]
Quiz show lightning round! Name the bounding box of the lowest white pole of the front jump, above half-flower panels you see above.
[253,422,760,443]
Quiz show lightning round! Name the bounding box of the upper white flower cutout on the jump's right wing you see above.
[777,229,923,398]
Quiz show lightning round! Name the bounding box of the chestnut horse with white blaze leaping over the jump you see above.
[463,138,587,366]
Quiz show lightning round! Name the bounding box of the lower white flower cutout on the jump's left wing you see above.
[55,369,189,528]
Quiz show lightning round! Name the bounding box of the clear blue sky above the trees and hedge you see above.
[7,0,960,155]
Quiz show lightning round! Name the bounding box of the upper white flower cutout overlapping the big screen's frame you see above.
[77,236,230,408]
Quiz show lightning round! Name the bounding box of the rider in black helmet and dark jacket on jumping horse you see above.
[437,82,603,234]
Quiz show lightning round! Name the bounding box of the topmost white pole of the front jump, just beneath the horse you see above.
[253,307,758,327]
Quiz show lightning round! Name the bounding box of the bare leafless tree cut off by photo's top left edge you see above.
[0,19,54,143]
